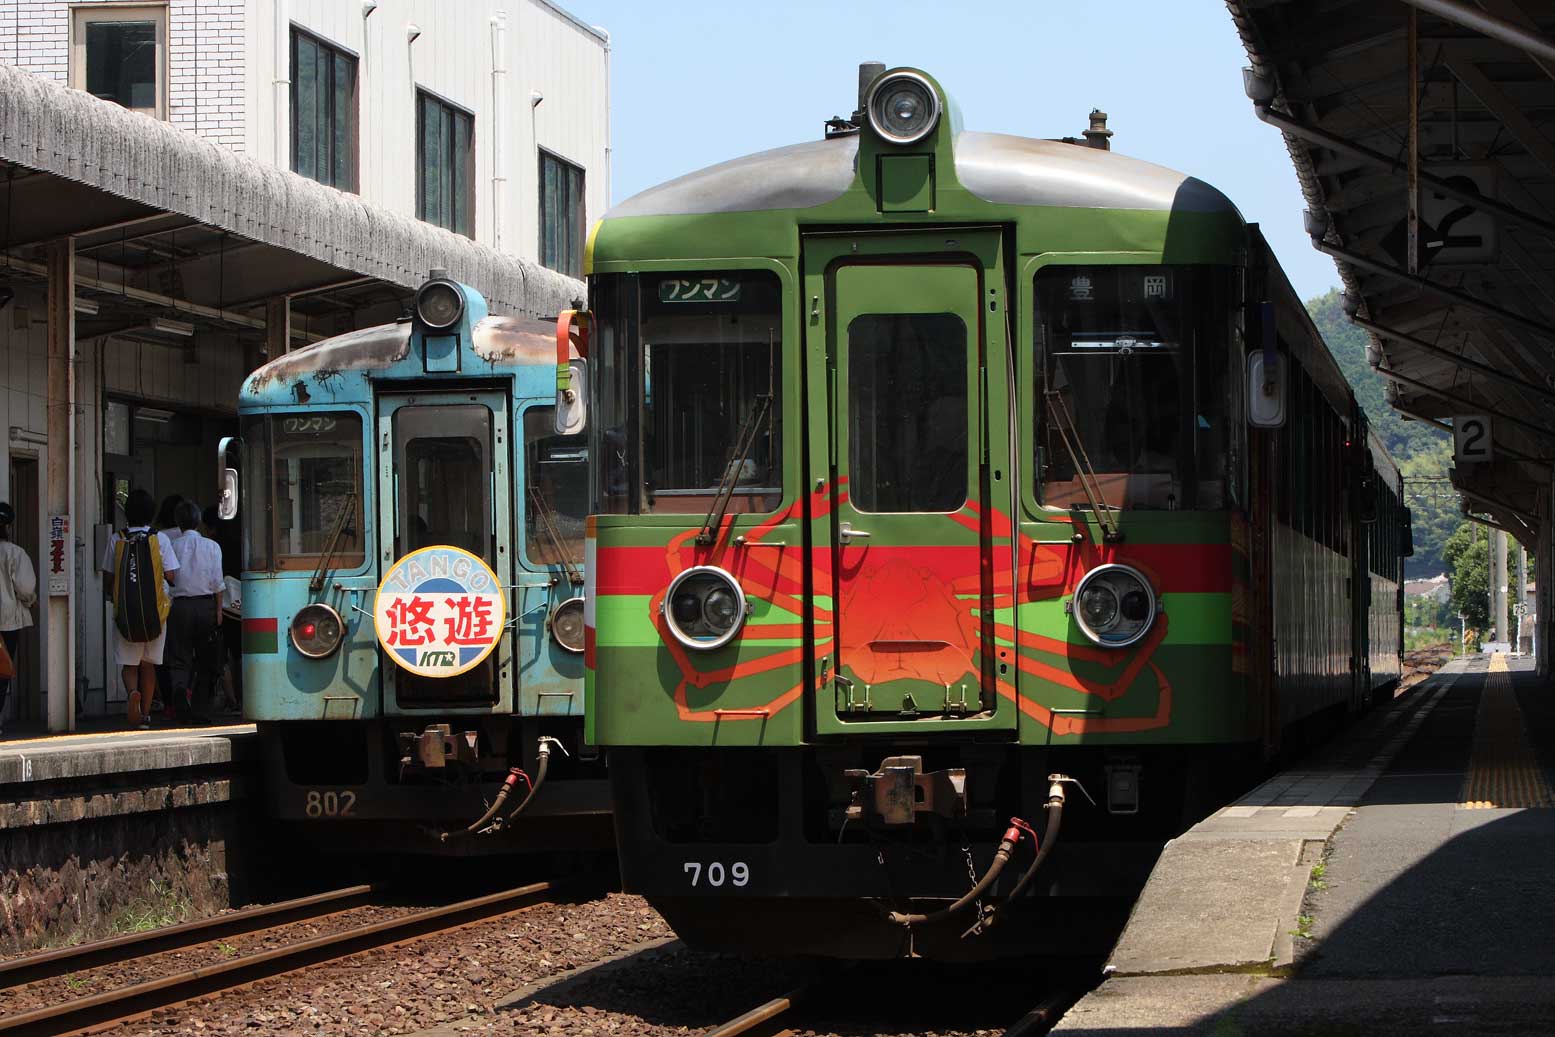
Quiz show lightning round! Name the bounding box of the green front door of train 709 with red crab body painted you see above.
[804,229,1015,737]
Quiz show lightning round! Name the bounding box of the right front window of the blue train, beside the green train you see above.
[524,404,588,566]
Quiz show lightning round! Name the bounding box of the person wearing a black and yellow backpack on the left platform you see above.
[100,490,179,729]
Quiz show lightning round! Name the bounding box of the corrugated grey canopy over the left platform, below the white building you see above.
[0,65,583,351]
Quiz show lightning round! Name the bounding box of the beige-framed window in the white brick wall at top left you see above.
[70,5,168,118]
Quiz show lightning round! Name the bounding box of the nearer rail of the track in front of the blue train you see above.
[0,882,560,1037]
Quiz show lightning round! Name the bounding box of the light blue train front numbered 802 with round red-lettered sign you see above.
[238,271,610,854]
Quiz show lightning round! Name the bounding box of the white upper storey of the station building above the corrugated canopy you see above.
[0,0,610,277]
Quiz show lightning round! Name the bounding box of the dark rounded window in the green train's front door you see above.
[847,312,969,513]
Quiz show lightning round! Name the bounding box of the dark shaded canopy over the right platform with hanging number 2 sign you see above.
[1228,0,1555,547]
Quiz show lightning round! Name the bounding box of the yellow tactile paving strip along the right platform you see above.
[1459,655,1555,810]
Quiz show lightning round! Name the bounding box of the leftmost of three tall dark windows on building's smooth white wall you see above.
[291,28,356,191]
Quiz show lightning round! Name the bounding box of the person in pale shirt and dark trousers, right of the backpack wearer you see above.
[168,501,227,720]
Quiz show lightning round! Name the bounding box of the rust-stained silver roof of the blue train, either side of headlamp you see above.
[243,317,577,396]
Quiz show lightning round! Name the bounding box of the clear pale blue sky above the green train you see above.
[561,0,1339,299]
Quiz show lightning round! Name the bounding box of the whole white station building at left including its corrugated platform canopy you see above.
[0,0,610,731]
